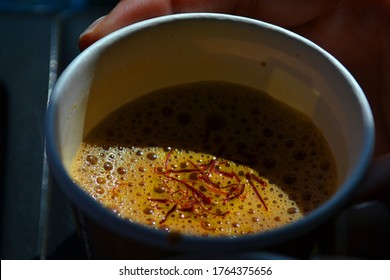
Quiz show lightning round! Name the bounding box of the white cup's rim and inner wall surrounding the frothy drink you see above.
[46,13,374,258]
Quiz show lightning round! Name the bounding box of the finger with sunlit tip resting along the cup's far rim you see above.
[79,0,339,49]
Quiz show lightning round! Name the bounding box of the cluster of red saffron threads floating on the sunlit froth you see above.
[148,150,268,230]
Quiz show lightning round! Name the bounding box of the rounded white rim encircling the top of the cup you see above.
[45,13,374,251]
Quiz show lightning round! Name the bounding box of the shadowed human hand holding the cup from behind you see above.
[79,0,390,201]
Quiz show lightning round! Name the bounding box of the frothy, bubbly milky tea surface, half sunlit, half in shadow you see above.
[71,81,337,236]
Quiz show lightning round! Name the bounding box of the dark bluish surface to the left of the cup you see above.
[0,1,110,259]
